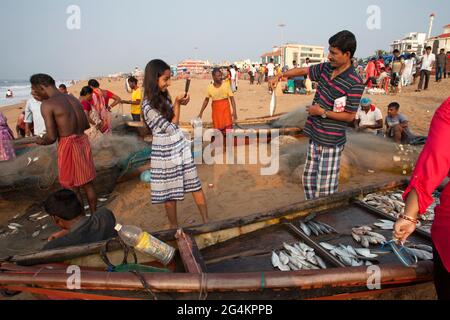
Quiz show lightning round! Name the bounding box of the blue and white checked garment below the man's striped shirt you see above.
[303,141,344,200]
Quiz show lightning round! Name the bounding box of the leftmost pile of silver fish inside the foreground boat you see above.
[272,242,327,271]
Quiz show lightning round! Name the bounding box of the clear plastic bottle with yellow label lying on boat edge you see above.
[115,224,175,265]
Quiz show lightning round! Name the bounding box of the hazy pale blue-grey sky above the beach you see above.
[0,0,450,79]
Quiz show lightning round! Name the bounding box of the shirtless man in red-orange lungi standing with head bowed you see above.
[30,74,97,213]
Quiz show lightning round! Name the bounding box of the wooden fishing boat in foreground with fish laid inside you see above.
[0,181,435,300]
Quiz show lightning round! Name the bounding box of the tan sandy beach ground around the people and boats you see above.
[0,79,450,231]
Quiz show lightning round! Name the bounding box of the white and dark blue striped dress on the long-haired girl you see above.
[142,101,202,204]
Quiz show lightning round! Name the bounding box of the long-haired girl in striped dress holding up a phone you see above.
[142,60,208,229]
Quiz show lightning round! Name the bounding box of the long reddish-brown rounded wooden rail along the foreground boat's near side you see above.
[0,261,433,295]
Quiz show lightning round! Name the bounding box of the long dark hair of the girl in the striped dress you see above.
[144,59,175,122]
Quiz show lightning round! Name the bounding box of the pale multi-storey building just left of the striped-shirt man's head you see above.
[261,44,325,68]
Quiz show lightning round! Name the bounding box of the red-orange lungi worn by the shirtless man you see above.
[58,134,96,188]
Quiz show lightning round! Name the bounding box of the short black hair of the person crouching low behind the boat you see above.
[44,190,83,221]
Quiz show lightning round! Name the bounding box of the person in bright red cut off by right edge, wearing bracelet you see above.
[394,98,450,300]
